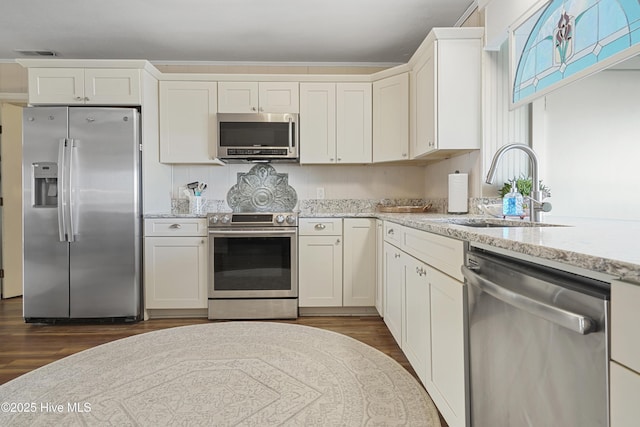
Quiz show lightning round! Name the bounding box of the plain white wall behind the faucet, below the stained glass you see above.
[541,70,640,220]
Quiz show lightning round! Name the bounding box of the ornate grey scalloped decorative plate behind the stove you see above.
[227,164,298,212]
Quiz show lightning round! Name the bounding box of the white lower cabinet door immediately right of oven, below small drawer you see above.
[298,236,342,307]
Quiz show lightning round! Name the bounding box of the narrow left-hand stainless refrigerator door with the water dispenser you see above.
[22,107,69,318]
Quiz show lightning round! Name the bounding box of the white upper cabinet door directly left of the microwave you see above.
[160,81,217,163]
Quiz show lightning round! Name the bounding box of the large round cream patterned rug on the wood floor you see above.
[0,322,440,427]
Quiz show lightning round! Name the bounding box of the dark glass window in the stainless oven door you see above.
[213,237,291,291]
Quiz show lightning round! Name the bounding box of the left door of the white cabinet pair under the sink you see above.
[402,256,431,384]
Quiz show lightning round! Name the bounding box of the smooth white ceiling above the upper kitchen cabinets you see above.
[0,0,474,65]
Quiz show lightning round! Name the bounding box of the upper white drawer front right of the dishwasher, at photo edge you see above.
[611,280,640,372]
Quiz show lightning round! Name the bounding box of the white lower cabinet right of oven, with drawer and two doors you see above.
[298,218,376,308]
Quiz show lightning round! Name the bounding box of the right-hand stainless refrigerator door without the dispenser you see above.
[69,108,141,318]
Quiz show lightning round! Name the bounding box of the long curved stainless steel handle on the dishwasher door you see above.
[461,265,596,335]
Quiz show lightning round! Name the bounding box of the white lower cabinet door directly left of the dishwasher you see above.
[427,267,467,426]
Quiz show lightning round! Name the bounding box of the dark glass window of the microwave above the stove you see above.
[220,122,296,147]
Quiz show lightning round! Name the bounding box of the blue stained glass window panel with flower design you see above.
[511,0,640,104]
